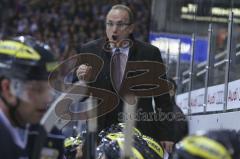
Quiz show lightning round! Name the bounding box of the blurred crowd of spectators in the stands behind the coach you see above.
[0,0,151,60]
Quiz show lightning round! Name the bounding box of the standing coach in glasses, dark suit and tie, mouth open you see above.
[76,5,174,152]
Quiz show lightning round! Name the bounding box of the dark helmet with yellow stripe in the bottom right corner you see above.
[173,130,240,159]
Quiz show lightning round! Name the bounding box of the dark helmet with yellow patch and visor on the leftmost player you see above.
[0,36,56,80]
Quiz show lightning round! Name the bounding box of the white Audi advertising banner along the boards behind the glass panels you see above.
[176,80,240,114]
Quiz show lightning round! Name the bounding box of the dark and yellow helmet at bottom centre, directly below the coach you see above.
[97,132,163,159]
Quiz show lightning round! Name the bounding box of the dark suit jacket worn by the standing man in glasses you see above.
[75,38,174,141]
